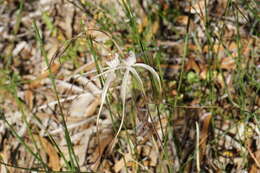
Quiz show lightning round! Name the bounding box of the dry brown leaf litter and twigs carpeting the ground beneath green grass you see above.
[0,0,260,173]
